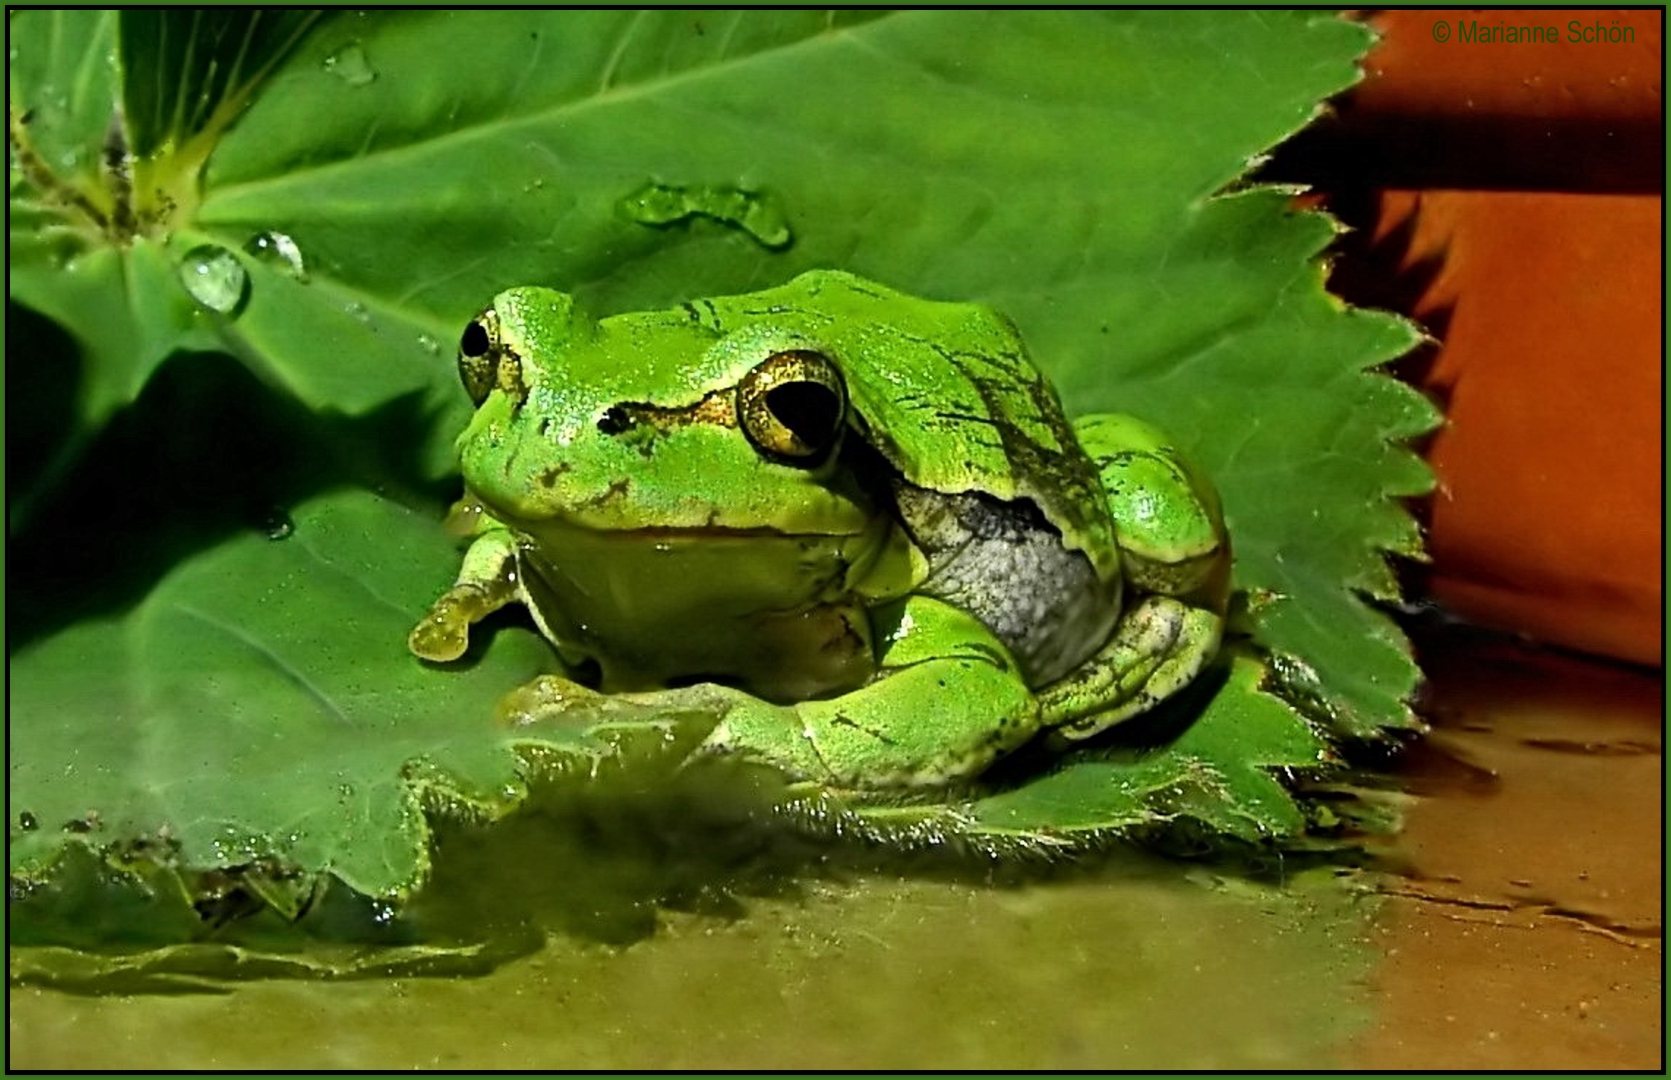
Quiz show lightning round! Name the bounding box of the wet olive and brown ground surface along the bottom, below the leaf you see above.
[8,637,1663,1070]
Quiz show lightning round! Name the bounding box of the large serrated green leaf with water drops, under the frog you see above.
[8,12,1434,929]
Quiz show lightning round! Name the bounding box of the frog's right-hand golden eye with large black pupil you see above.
[737,349,847,466]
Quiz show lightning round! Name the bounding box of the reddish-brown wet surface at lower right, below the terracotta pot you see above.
[1354,630,1664,1070]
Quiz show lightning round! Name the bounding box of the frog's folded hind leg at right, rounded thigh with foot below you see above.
[1039,415,1230,739]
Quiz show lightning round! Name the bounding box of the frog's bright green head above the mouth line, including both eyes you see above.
[458,288,874,535]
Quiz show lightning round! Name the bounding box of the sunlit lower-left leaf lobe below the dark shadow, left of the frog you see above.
[7,492,561,896]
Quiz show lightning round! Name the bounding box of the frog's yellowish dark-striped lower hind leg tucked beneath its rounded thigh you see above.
[1039,595,1223,739]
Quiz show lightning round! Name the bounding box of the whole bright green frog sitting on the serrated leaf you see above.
[409,271,1230,787]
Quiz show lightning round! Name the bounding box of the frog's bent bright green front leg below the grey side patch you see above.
[709,597,1039,787]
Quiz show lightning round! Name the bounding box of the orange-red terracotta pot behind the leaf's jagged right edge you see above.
[1273,10,1666,667]
